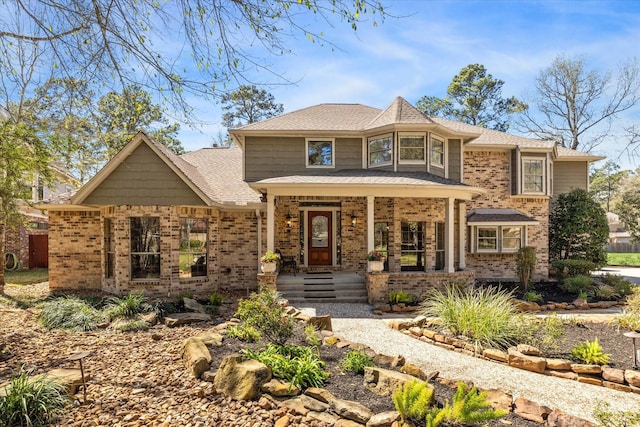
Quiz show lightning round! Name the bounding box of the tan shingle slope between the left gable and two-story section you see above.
[180,147,260,205]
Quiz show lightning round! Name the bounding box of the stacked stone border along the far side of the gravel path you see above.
[388,316,640,394]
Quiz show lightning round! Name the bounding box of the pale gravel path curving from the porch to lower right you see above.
[298,304,640,421]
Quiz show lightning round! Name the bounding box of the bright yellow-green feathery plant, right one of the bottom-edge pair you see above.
[426,382,507,427]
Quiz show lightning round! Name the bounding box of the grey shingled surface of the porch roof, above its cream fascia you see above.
[250,169,468,187]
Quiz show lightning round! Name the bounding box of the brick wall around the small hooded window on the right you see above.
[464,151,549,280]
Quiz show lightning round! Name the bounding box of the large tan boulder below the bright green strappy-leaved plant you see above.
[214,354,271,400]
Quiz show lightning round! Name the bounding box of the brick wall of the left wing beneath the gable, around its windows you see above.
[49,206,258,297]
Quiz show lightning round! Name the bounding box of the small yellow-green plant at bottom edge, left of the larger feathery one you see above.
[392,380,433,424]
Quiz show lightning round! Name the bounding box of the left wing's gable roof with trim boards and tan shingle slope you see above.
[69,132,260,206]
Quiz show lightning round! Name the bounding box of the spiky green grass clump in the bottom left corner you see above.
[0,368,71,426]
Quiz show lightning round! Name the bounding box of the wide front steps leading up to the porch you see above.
[276,271,367,303]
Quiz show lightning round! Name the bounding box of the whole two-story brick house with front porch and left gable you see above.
[43,98,600,300]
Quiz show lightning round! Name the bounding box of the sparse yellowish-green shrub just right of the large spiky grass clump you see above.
[515,314,567,354]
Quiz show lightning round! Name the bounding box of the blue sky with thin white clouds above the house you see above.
[180,0,640,167]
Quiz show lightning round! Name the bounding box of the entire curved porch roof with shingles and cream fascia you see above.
[249,169,486,200]
